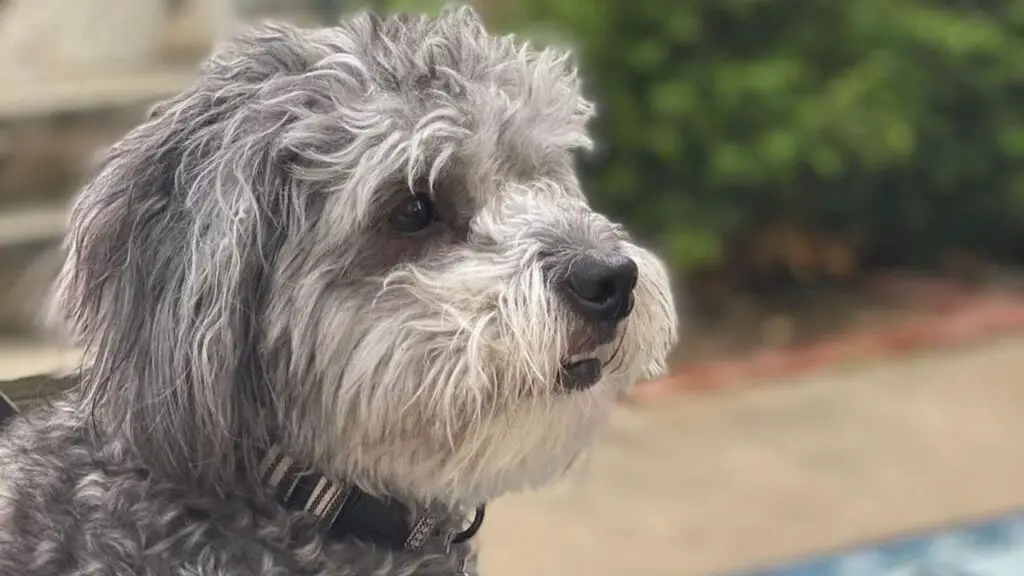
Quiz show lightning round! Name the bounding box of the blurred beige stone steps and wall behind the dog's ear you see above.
[0,0,319,338]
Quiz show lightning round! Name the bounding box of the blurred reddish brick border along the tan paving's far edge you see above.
[629,277,1024,403]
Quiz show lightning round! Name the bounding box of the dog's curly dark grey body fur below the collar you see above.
[0,401,475,576]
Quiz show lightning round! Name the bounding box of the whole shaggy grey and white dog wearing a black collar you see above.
[0,7,677,576]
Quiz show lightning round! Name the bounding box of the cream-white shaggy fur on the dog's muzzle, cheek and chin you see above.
[285,233,676,504]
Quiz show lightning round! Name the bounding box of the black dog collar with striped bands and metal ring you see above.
[260,447,484,550]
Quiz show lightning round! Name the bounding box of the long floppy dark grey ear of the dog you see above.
[55,27,315,484]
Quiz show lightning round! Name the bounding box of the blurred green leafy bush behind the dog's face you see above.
[360,0,1024,277]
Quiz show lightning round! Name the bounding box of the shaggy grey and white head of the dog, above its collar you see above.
[57,8,676,502]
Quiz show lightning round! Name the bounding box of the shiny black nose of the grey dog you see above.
[564,254,637,322]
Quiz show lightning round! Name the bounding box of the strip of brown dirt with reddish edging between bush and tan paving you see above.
[633,271,1024,401]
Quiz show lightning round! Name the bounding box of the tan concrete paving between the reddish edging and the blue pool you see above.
[0,339,1024,576]
